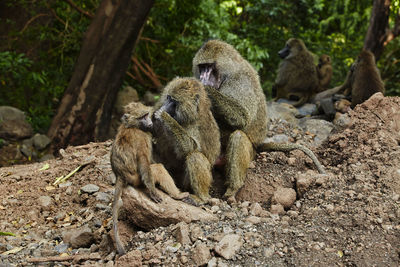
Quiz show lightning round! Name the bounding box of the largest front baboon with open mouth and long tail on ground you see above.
[193,40,323,198]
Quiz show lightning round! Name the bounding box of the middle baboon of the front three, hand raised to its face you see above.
[153,78,220,202]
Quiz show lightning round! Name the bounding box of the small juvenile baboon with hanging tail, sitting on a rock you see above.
[110,102,189,255]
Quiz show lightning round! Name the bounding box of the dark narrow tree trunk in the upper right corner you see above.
[364,0,390,61]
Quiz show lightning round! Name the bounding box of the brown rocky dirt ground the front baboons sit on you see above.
[0,95,400,266]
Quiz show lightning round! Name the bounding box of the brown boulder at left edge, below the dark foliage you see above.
[0,106,33,140]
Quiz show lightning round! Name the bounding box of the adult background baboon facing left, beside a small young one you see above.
[272,38,319,107]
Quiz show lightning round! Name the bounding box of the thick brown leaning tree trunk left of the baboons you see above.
[48,0,154,153]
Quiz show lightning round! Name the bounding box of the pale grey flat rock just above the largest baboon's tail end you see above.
[300,118,334,146]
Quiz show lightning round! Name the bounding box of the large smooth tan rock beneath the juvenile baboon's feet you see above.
[122,187,217,230]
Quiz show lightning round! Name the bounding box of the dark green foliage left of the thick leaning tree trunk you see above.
[0,0,99,133]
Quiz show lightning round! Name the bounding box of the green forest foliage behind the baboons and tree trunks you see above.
[0,0,400,133]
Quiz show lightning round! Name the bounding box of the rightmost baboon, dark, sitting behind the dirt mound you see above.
[315,50,385,108]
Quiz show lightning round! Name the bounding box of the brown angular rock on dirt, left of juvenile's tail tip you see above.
[62,226,95,248]
